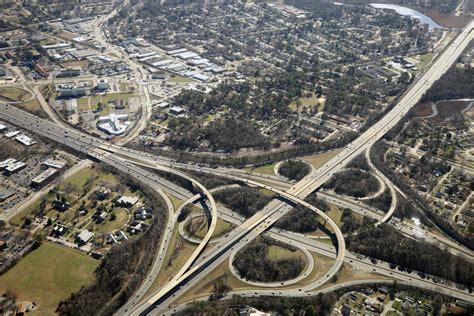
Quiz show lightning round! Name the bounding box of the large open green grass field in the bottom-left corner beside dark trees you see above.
[0,243,99,315]
